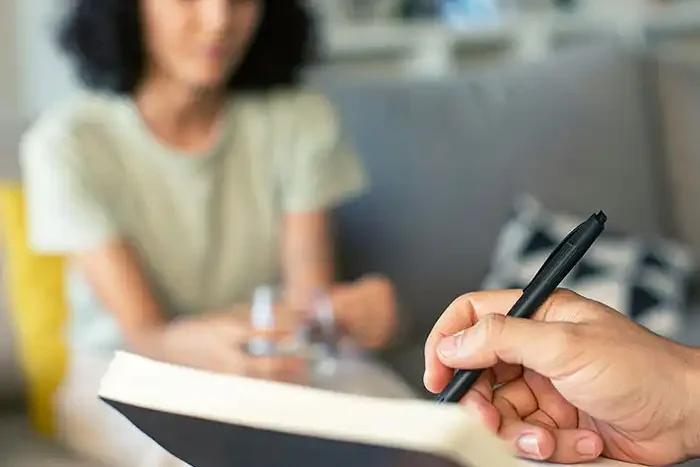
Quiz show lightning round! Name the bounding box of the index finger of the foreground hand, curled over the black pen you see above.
[423,290,522,393]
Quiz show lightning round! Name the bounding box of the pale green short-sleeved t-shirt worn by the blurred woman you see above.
[21,91,365,352]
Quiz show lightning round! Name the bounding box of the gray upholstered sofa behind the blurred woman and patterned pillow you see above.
[0,44,700,467]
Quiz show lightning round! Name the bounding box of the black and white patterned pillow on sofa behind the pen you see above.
[484,196,695,337]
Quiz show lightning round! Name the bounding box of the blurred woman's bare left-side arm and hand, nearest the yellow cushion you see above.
[70,240,286,376]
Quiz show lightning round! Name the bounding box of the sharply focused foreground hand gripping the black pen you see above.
[425,291,700,465]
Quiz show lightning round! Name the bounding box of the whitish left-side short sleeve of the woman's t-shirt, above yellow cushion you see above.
[20,122,118,254]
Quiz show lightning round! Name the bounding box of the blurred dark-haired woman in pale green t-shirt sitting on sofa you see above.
[21,0,396,467]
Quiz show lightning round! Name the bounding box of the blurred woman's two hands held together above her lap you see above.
[150,276,396,381]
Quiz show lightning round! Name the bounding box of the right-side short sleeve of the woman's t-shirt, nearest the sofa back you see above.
[282,94,367,212]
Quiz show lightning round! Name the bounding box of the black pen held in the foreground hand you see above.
[437,211,608,402]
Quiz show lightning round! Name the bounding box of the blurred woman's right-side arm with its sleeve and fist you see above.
[279,94,404,349]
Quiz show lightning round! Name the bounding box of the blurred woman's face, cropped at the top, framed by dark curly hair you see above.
[141,0,263,88]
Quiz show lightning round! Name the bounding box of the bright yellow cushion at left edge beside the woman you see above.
[0,183,67,436]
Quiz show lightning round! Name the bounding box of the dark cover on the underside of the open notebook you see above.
[102,398,468,467]
